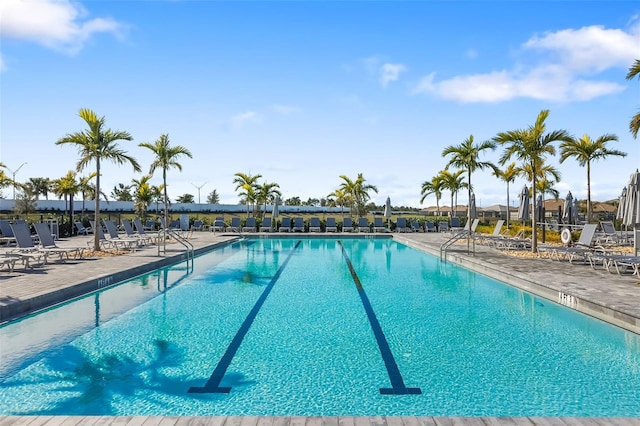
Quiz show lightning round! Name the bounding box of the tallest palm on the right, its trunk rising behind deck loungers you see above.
[492,109,572,253]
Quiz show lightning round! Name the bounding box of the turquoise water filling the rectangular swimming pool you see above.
[0,239,640,416]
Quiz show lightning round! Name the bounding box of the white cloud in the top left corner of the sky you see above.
[0,0,124,54]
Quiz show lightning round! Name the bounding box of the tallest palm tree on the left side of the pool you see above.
[56,108,141,251]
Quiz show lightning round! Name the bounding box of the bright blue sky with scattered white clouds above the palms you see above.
[0,0,640,207]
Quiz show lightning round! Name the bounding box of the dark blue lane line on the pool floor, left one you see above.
[188,240,302,393]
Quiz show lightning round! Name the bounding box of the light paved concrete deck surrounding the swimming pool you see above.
[0,232,640,426]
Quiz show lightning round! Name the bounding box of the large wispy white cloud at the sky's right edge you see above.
[413,25,640,103]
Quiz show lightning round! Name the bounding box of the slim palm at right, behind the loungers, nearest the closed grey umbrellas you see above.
[560,134,627,222]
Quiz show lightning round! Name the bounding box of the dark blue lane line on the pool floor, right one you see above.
[338,241,422,395]
